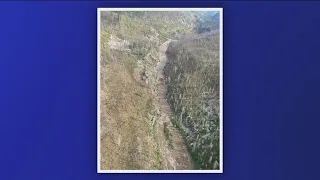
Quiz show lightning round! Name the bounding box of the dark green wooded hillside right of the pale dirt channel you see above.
[165,32,220,169]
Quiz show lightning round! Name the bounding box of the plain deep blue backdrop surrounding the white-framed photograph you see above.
[0,1,320,180]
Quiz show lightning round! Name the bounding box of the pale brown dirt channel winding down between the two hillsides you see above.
[156,40,193,170]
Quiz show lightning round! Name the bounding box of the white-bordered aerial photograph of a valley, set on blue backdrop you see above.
[97,8,223,173]
